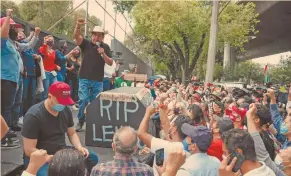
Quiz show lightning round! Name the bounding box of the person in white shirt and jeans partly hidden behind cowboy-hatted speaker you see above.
[103,60,116,91]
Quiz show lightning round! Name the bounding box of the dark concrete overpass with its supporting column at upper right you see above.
[224,1,291,65]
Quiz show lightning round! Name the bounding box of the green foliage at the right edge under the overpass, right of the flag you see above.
[270,58,291,84]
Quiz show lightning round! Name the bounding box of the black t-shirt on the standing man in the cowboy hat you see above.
[79,39,112,82]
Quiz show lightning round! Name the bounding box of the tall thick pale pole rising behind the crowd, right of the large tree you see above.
[205,0,219,83]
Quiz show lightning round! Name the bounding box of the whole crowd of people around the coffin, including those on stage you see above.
[1,9,291,176]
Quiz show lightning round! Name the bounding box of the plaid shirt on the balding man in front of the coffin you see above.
[91,156,154,176]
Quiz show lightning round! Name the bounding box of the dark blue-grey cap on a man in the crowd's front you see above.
[181,123,213,151]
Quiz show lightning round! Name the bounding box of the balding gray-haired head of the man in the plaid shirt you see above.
[113,126,138,155]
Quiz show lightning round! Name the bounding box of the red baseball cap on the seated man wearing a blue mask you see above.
[49,81,75,106]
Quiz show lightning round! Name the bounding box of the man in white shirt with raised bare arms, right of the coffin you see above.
[138,105,192,175]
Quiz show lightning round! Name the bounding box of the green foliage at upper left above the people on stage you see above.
[14,1,102,39]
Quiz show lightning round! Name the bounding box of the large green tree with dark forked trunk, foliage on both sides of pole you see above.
[132,1,257,82]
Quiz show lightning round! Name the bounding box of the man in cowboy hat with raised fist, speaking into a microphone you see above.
[74,18,113,131]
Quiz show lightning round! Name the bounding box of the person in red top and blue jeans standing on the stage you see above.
[39,35,61,100]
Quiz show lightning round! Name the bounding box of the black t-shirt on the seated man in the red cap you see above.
[21,101,74,155]
